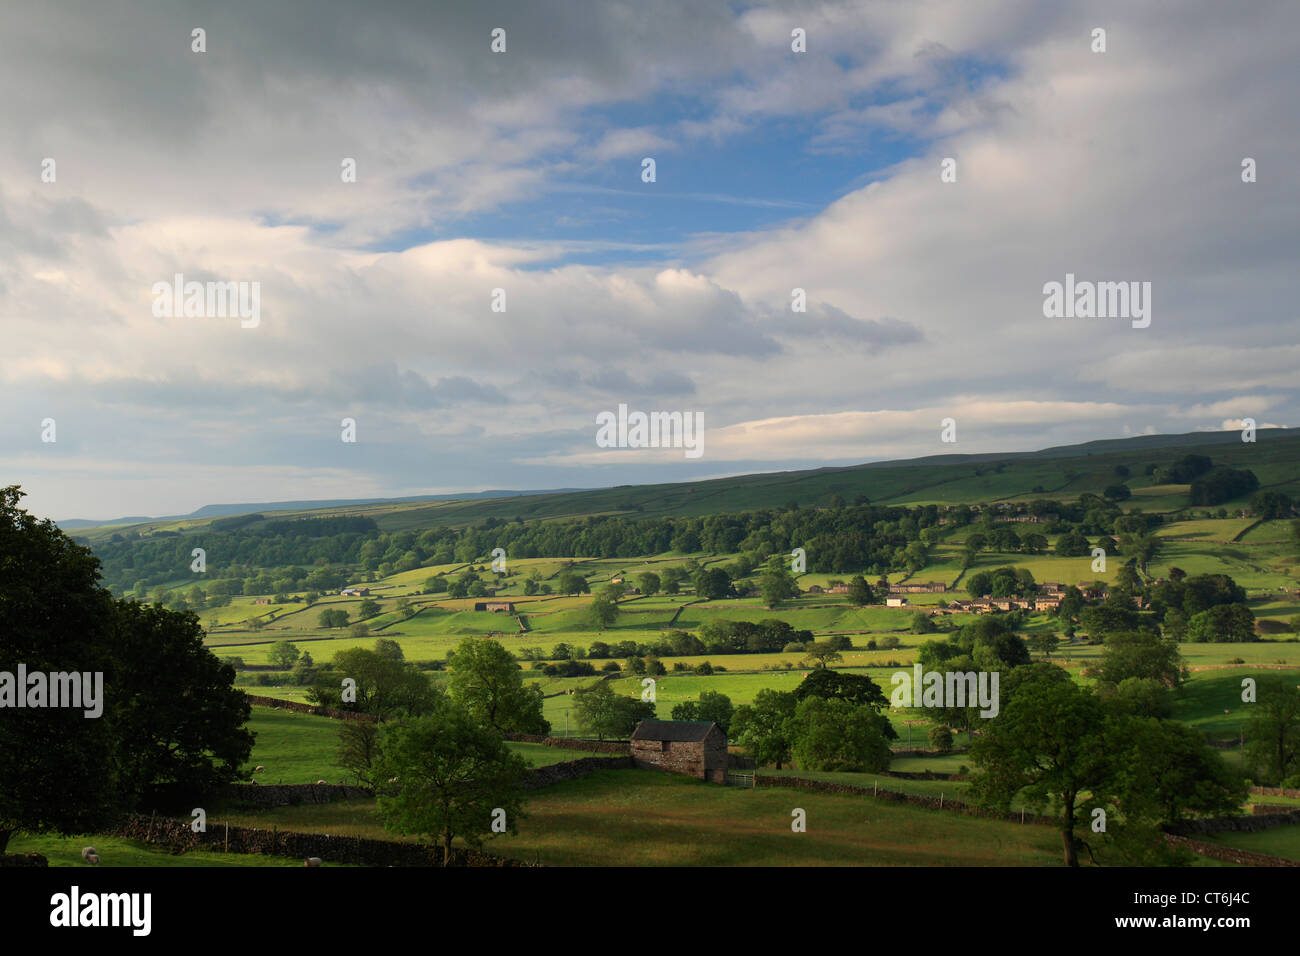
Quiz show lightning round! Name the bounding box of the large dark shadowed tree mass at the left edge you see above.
[0,488,252,851]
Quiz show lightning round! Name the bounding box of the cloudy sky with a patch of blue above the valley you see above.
[0,0,1300,519]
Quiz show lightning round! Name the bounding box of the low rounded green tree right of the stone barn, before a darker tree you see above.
[790,697,891,773]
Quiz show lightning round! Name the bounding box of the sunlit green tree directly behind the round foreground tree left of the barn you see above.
[451,637,551,735]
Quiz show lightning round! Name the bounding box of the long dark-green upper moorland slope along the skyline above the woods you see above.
[73,429,1300,541]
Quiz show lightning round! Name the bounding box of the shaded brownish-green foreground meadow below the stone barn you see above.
[210,770,1061,866]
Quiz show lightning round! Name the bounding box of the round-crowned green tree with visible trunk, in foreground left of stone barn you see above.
[377,701,528,866]
